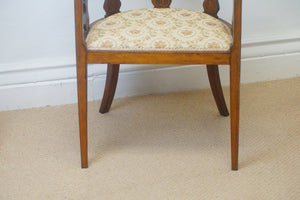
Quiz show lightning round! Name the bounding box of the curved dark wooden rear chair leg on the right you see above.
[206,65,229,116]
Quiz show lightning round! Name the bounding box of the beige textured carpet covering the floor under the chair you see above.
[0,78,300,200]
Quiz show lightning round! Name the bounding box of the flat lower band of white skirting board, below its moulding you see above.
[0,54,300,111]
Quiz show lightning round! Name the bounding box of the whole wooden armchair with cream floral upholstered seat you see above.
[74,0,242,170]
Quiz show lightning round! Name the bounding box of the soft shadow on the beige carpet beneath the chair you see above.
[89,92,230,164]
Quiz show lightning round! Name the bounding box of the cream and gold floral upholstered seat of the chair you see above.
[86,8,232,52]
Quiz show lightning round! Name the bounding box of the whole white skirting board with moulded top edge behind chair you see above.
[0,37,300,111]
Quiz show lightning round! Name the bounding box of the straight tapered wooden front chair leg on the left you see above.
[77,58,88,168]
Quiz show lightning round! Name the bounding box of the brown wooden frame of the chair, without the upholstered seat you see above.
[74,0,242,170]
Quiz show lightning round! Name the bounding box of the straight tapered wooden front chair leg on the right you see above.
[230,59,241,170]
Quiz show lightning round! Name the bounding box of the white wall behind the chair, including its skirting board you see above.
[0,0,300,110]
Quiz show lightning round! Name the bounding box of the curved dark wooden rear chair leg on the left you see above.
[99,64,120,114]
